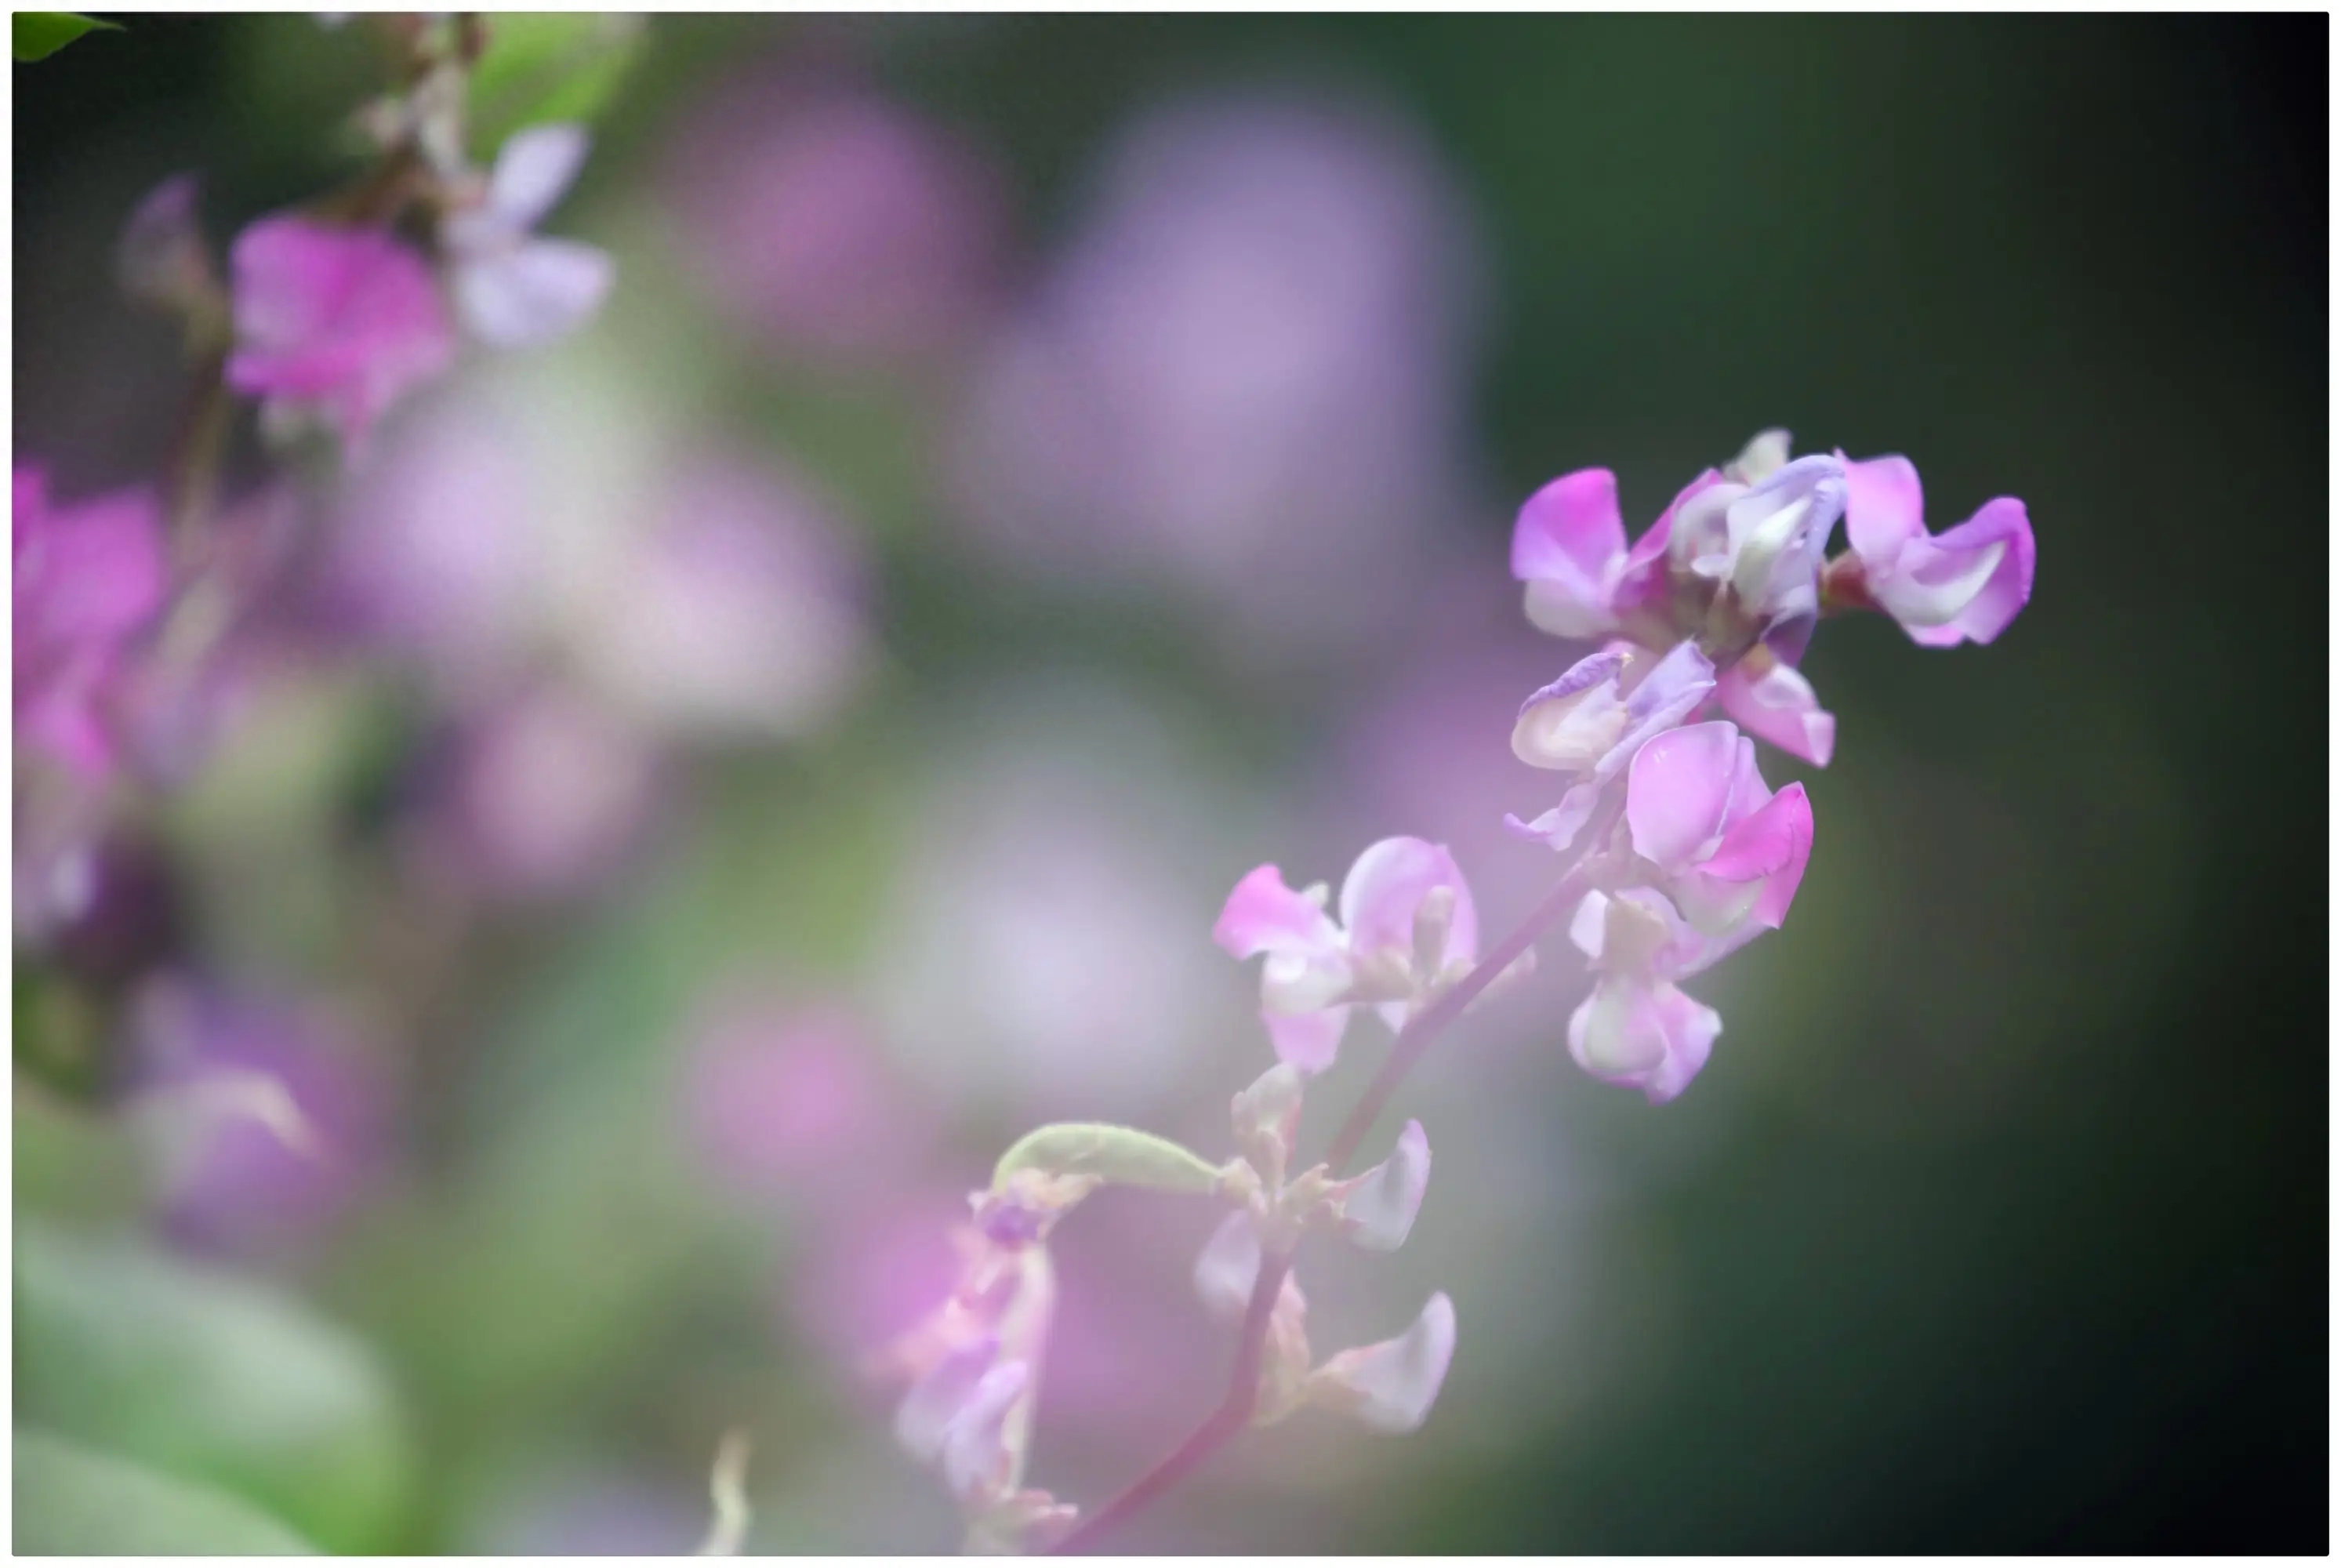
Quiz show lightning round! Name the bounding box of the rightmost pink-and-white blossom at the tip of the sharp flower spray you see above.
[1838,454,2032,648]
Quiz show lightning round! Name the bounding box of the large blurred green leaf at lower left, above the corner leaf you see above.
[16,1217,408,1552]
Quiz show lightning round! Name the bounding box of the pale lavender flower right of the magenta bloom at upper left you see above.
[440,124,613,349]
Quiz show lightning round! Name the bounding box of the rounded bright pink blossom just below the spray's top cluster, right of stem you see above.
[1624,720,1812,936]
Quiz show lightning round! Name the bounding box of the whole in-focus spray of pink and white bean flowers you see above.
[895,430,2032,1549]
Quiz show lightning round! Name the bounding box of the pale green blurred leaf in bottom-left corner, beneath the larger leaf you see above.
[14,1428,316,1556]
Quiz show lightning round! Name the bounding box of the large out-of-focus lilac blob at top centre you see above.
[957,98,1475,651]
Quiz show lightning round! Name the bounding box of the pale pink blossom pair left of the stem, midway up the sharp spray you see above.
[1213,838,1479,1072]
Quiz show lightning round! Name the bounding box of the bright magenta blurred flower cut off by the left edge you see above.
[9,466,166,782]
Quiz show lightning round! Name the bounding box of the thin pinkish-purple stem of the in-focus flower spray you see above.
[1051,784,1624,1554]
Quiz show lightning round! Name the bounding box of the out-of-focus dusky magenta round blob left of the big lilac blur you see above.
[670,75,1000,361]
